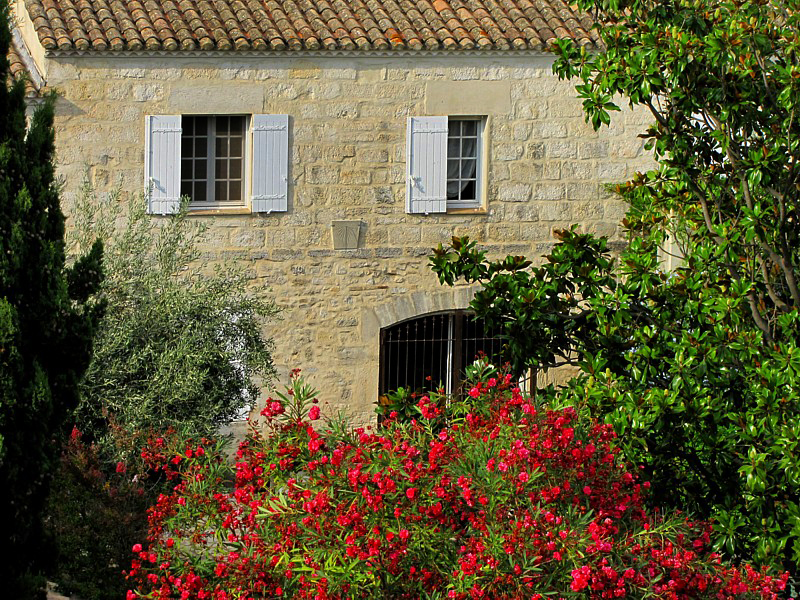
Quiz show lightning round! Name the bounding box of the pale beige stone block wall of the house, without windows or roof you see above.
[37,53,648,422]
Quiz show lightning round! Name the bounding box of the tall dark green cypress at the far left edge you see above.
[0,1,102,598]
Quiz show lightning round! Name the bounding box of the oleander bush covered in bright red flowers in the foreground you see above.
[128,374,787,600]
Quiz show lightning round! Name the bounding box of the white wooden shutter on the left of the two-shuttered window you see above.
[144,115,181,215]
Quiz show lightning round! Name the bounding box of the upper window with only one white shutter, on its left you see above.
[406,117,486,214]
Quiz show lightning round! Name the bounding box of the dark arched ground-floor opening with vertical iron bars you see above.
[379,310,503,395]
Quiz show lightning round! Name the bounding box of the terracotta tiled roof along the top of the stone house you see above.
[20,0,598,52]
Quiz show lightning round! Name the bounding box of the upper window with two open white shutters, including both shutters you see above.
[145,115,289,214]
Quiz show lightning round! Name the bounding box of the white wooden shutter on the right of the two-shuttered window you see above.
[252,115,289,212]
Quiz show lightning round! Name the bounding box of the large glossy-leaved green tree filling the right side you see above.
[432,0,800,576]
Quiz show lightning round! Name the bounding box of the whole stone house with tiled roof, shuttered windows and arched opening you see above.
[11,0,648,422]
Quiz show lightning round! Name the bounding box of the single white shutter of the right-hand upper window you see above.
[406,117,447,214]
